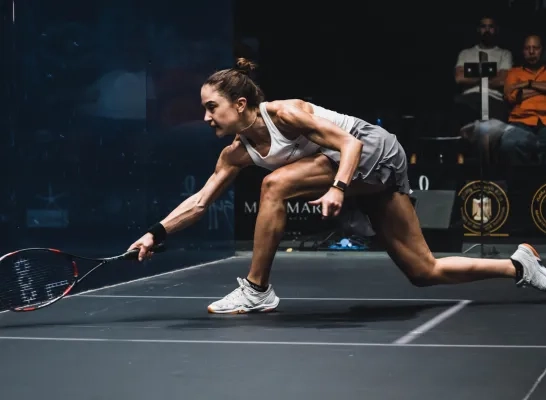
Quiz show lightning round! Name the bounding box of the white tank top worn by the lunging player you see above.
[240,102,354,171]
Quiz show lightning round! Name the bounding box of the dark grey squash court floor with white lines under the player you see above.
[0,253,546,400]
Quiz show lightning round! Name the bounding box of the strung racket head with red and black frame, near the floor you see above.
[0,248,79,312]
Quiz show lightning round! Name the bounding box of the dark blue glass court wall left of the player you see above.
[0,0,234,284]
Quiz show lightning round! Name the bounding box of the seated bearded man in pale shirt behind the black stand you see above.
[455,17,512,127]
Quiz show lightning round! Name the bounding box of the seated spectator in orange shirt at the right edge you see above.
[500,35,546,165]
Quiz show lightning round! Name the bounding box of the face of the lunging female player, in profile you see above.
[201,85,240,137]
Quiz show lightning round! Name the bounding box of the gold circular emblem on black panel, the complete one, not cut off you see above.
[459,181,510,234]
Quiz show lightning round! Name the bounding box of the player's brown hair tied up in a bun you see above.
[203,58,265,108]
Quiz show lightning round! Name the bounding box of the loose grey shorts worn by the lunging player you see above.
[320,118,411,195]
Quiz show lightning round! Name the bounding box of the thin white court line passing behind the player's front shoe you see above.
[79,294,470,303]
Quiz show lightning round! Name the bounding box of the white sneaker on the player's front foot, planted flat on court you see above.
[208,278,279,314]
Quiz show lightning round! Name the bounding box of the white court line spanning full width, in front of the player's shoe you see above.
[0,336,546,350]
